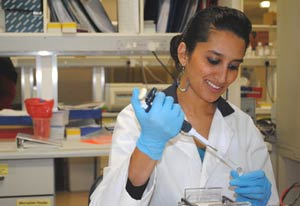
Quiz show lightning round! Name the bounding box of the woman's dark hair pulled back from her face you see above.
[170,6,252,70]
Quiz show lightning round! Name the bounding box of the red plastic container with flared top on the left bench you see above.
[25,98,54,138]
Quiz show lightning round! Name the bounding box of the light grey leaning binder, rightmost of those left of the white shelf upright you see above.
[80,0,115,32]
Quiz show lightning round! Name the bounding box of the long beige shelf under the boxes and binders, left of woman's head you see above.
[0,33,176,56]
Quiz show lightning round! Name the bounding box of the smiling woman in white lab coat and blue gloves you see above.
[90,7,278,206]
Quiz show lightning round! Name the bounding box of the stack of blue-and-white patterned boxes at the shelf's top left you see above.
[2,0,44,32]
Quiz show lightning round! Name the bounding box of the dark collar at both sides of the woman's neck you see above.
[163,82,234,117]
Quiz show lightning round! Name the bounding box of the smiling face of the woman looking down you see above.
[178,30,245,103]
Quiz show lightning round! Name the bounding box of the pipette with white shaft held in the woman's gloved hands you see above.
[143,87,243,175]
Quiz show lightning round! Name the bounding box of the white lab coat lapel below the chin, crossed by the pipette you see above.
[200,109,233,187]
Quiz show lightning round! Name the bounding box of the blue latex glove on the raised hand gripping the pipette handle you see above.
[131,88,184,160]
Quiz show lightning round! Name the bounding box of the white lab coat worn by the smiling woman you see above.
[90,102,279,206]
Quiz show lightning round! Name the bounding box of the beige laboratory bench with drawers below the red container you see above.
[0,140,110,206]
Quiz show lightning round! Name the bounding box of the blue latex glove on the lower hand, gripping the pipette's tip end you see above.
[230,170,272,206]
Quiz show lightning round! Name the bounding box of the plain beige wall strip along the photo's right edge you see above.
[277,0,300,195]
